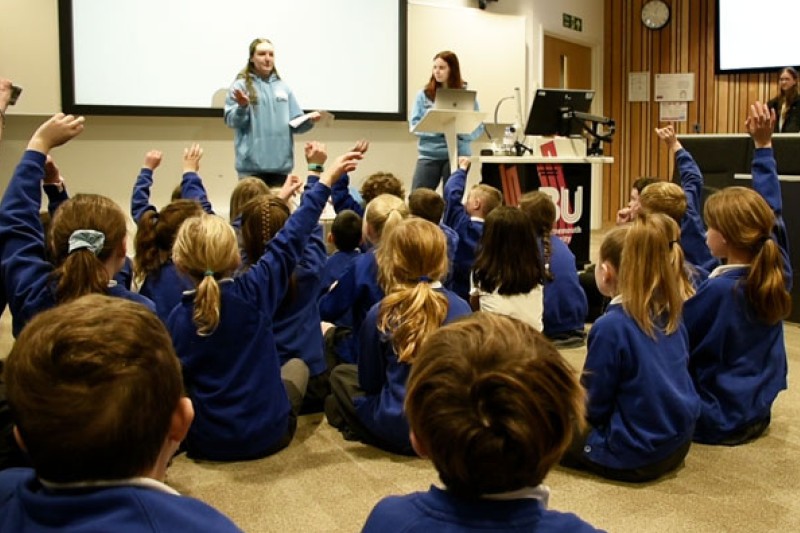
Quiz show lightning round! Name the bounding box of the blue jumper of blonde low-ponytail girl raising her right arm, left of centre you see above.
[167,183,330,461]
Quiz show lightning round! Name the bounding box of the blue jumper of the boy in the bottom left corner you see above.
[0,468,241,533]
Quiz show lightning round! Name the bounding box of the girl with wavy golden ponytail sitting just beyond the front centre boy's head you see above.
[325,216,470,454]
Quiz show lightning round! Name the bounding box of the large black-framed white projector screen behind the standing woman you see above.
[59,0,406,120]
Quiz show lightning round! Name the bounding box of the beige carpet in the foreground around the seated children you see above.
[158,324,800,533]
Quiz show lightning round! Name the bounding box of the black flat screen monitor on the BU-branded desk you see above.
[525,89,594,137]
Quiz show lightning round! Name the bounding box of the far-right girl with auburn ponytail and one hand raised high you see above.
[684,102,792,445]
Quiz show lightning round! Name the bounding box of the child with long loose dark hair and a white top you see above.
[470,205,544,331]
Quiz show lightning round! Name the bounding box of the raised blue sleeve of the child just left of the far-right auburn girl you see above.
[675,148,719,272]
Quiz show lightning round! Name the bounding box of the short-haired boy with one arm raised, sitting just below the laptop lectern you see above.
[444,157,503,300]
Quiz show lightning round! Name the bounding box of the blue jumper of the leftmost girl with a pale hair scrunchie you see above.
[0,150,155,337]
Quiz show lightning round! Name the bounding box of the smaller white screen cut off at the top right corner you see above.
[716,0,800,74]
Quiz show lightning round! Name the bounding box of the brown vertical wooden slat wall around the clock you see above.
[603,0,779,223]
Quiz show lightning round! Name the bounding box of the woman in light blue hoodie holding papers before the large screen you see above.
[225,39,322,187]
